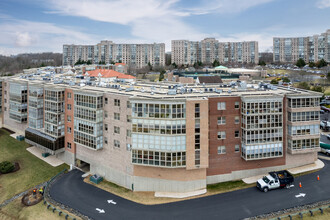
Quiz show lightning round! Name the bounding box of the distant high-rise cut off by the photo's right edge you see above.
[273,29,330,63]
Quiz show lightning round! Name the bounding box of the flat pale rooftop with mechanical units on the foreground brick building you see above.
[7,70,322,99]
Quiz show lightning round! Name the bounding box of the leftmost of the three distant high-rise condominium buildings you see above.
[63,41,165,68]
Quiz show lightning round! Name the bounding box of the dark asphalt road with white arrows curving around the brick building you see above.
[50,160,330,220]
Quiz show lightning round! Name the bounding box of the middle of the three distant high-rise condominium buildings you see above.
[171,38,259,65]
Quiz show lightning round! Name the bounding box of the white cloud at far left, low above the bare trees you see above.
[0,19,96,55]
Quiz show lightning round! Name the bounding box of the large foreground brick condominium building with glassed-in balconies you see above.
[2,76,321,192]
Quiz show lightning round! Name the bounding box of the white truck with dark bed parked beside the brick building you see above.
[257,170,294,192]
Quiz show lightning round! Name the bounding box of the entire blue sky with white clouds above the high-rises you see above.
[0,0,330,55]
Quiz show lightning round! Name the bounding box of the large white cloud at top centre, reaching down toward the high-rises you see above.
[40,0,273,51]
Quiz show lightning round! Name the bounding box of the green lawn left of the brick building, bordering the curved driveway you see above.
[0,129,68,203]
